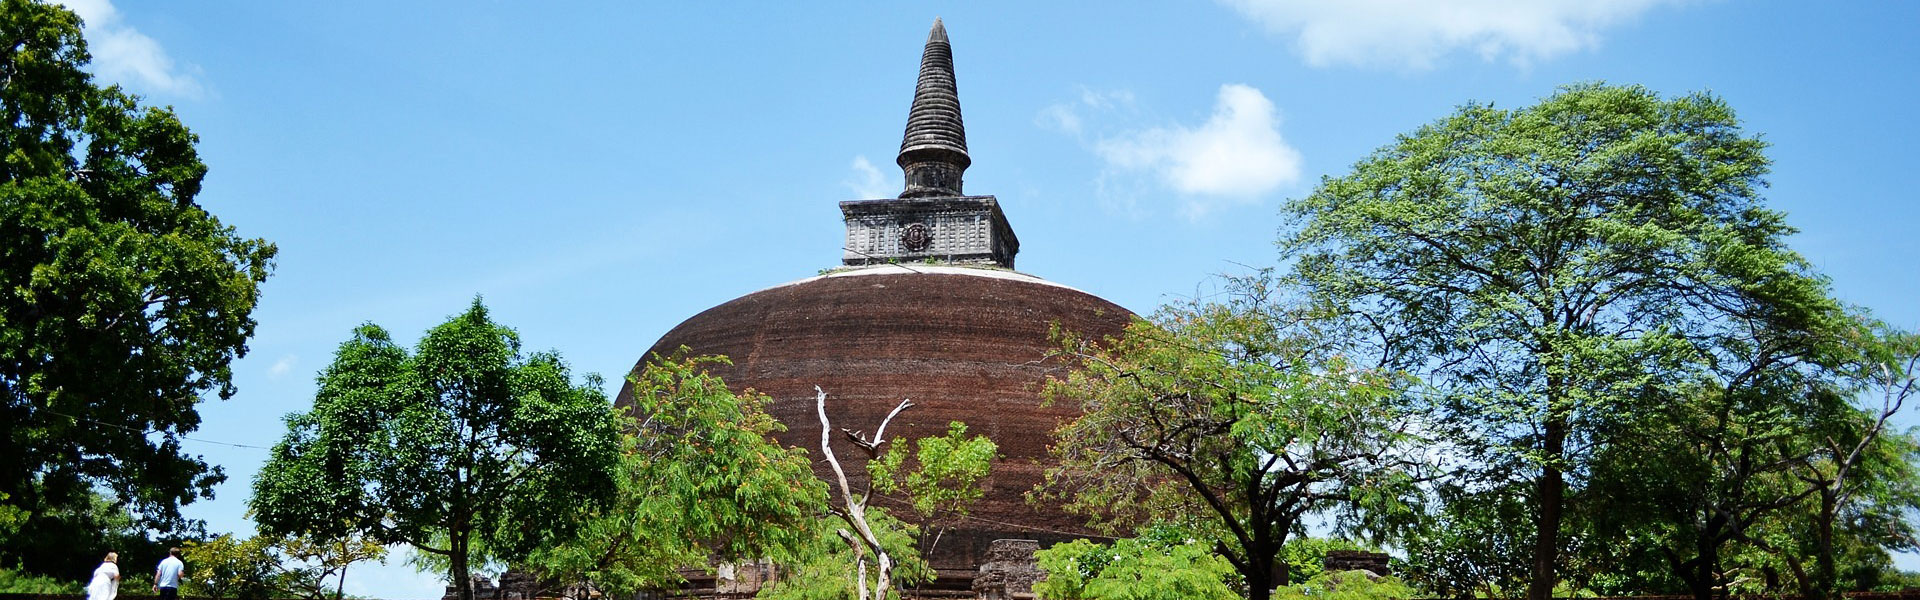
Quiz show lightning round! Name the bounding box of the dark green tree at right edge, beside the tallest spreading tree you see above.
[1590,317,1916,598]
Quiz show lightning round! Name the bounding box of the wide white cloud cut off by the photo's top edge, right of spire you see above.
[1223,0,1686,69]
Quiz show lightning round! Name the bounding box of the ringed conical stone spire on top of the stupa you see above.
[897,17,973,198]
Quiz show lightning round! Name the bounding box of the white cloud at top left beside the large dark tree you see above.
[60,0,202,98]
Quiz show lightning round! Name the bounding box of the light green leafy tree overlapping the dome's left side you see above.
[530,348,826,592]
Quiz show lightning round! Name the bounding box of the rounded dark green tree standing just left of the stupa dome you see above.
[250,298,620,600]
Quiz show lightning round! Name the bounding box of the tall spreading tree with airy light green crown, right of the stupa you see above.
[1279,85,1834,600]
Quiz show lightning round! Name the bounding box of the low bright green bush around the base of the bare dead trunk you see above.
[755,508,933,600]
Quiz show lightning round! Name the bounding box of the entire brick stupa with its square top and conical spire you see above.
[616,19,1133,587]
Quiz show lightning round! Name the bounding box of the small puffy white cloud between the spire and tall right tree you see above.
[1083,85,1300,217]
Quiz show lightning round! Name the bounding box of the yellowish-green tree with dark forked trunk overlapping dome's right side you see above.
[1041,275,1413,600]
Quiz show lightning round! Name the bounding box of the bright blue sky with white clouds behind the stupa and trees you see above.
[48,0,1920,598]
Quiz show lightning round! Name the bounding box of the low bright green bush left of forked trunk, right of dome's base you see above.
[1033,538,1238,600]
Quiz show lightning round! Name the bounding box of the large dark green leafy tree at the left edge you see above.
[0,0,275,542]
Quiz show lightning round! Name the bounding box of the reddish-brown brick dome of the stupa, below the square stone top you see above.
[618,265,1131,579]
